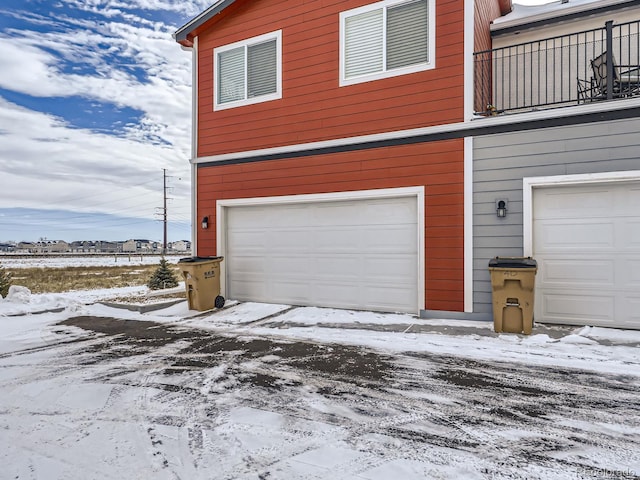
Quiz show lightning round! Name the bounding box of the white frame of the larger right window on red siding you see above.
[340,0,436,87]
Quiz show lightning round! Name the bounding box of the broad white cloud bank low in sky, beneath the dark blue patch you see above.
[0,100,189,220]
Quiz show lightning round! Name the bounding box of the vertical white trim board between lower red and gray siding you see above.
[464,137,473,313]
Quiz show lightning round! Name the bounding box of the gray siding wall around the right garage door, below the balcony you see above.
[473,119,640,319]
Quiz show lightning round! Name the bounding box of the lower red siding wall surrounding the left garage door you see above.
[196,140,464,311]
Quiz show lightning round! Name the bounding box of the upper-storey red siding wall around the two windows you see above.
[198,0,464,157]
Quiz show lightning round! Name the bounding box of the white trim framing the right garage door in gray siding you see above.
[522,170,640,257]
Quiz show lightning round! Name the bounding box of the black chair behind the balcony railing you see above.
[592,52,640,100]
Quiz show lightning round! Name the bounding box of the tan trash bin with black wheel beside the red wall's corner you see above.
[178,257,224,312]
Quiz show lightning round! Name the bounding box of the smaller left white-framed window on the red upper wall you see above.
[213,30,282,110]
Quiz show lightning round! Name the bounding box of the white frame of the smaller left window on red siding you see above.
[213,30,282,111]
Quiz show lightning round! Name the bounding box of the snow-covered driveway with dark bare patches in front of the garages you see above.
[0,287,640,480]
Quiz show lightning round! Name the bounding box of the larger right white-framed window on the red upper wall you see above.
[340,0,435,86]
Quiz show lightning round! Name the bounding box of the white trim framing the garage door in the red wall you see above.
[216,186,425,310]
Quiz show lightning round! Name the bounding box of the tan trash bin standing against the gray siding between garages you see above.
[489,257,538,335]
